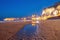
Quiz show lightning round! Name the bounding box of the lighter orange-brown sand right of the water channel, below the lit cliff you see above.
[39,19,60,40]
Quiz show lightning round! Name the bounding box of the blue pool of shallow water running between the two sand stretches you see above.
[10,24,38,40]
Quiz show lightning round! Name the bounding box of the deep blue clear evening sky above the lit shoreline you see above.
[0,0,59,18]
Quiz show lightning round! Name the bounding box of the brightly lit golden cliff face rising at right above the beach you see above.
[42,5,60,20]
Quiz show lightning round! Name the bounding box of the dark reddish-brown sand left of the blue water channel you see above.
[0,22,28,40]
